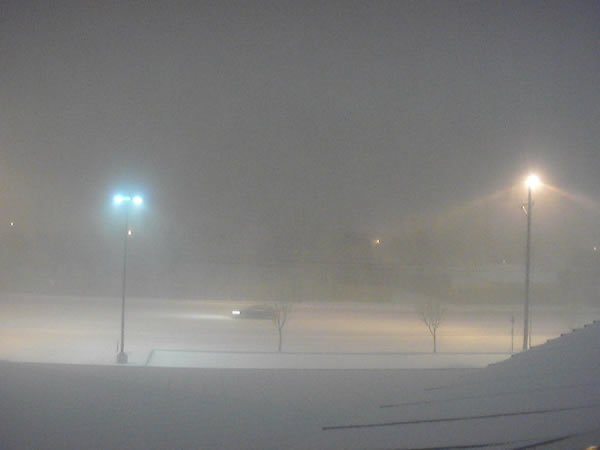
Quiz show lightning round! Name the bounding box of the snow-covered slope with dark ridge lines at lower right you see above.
[323,322,600,449]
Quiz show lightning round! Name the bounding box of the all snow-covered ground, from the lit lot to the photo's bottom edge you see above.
[0,295,600,450]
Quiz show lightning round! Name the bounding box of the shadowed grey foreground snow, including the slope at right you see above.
[0,322,600,449]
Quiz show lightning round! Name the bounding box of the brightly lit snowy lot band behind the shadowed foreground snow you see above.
[0,294,600,368]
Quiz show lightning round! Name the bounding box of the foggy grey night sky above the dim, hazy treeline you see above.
[0,0,600,268]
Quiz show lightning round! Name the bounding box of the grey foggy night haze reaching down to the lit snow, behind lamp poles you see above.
[0,0,600,305]
